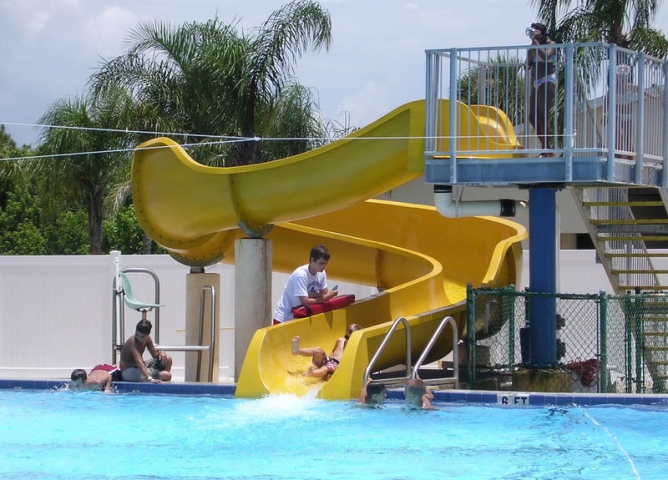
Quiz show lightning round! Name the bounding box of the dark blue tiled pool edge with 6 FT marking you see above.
[5,379,668,407]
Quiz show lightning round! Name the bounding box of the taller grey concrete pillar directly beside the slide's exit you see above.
[234,238,273,380]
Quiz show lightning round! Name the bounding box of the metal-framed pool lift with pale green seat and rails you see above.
[112,268,216,382]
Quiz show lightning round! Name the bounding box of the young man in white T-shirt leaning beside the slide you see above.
[273,245,338,325]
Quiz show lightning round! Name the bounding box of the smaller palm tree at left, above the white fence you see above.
[32,90,133,255]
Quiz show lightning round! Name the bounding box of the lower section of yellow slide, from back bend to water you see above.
[237,200,526,399]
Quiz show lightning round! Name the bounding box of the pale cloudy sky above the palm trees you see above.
[0,0,668,145]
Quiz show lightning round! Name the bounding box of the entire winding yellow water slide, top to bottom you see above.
[132,101,526,399]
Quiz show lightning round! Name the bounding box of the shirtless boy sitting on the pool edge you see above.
[119,320,172,383]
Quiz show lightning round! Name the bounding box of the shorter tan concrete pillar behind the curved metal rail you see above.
[185,273,220,383]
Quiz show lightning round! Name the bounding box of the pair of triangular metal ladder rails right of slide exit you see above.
[362,316,459,389]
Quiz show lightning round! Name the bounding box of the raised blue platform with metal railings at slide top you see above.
[425,43,668,189]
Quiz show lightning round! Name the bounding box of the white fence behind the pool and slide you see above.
[0,250,611,383]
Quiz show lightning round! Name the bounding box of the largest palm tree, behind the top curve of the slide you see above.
[91,0,331,166]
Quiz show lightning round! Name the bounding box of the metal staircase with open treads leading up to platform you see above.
[572,186,668,393]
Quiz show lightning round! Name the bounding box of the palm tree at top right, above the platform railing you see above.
[530,0,668,58]
